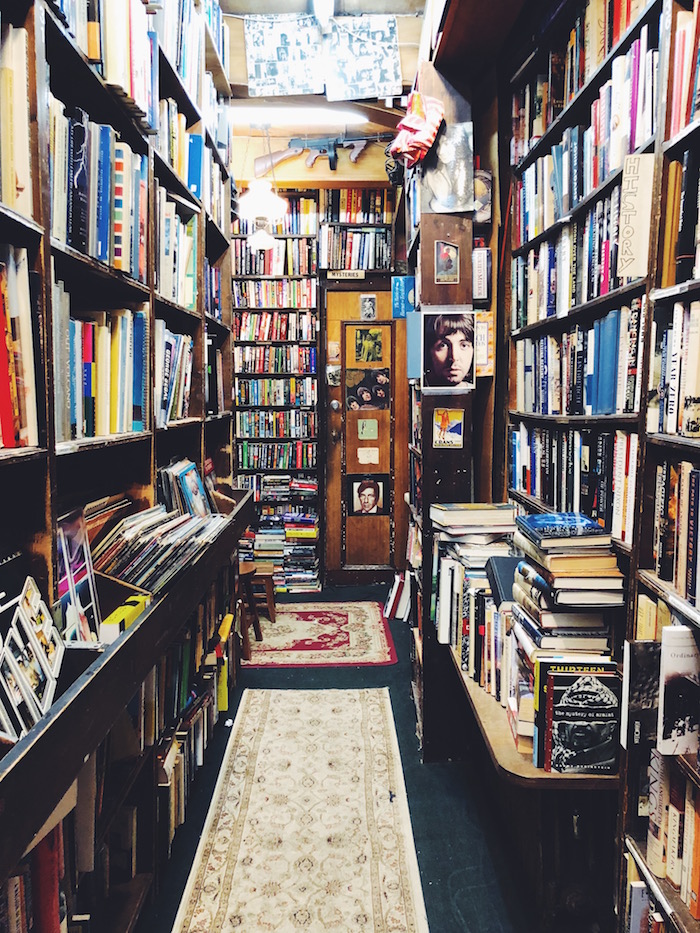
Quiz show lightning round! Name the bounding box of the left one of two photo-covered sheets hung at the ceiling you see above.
[244,13,324,97]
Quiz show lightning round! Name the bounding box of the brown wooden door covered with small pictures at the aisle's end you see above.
[325,288,408,583]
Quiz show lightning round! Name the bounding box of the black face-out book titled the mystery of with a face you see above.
[544,671,620,774]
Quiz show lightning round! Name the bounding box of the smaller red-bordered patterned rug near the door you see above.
[241,603,396,667]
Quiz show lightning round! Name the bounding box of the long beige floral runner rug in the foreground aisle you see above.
[173,688,428,933]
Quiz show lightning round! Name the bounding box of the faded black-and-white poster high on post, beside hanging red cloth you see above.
[421,123,474,214]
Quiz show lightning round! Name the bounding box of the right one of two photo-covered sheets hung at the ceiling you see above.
[324,15,403,100]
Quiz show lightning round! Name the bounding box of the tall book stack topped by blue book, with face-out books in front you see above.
[509,512,624,774]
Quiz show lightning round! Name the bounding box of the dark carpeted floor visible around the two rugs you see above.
[138,586,535,933]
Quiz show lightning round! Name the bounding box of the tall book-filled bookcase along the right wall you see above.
[508,2,700,933]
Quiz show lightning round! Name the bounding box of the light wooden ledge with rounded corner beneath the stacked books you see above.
[450,649,618,790]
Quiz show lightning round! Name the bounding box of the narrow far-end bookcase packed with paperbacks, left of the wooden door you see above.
[231,192,322,593]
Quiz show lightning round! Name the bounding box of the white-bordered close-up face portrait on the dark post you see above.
[421,305,474,395]
